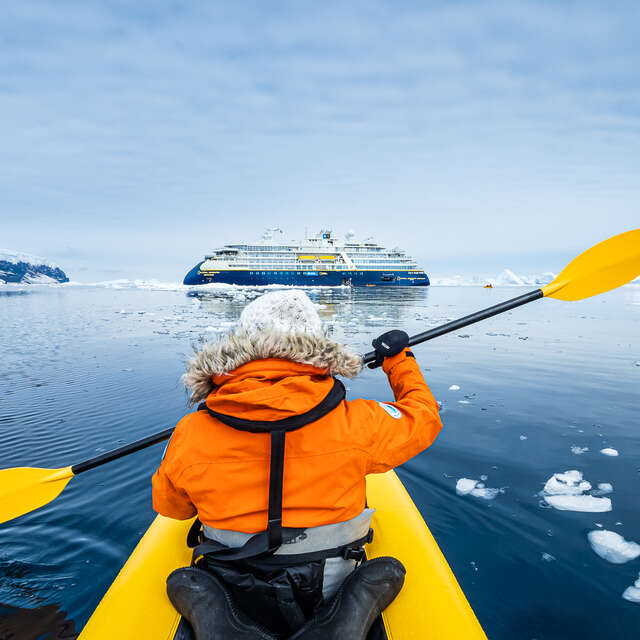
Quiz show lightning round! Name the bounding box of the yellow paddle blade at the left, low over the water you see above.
[0,467,73,523]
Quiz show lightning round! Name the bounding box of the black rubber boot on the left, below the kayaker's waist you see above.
[167,567,274,640]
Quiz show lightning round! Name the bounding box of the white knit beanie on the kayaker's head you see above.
[238,290,323,335]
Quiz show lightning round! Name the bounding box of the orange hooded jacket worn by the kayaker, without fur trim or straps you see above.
[152,351,442,533]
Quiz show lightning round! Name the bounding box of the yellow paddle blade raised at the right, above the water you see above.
[542,229,640,300]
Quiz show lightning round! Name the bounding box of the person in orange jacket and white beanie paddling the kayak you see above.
[153,291,442,640]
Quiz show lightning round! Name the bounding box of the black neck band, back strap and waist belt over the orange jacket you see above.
[187,378,350,562]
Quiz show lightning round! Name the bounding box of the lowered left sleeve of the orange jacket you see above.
[151,420,197,520]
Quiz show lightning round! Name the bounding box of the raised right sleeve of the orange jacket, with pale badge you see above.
[349,349,442,473]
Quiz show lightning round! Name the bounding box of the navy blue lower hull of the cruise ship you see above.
[184,263,429,287]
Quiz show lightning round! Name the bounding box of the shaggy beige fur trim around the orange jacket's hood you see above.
[182,329,362,403]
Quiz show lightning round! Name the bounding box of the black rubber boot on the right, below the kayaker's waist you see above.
[290,557,405,640]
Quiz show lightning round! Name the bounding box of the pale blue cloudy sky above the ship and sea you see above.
[0,0,640,281]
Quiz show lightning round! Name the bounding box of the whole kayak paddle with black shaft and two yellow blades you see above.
[0,229,640,523]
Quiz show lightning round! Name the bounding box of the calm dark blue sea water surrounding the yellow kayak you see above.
[0,285,640,640]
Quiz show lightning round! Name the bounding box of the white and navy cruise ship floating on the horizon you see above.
[184,227,429,287]
